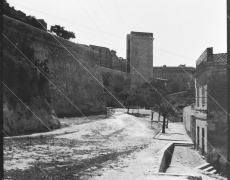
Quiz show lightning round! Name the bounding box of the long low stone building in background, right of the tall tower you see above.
[153,65,195,88]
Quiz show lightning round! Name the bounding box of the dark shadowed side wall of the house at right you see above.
[207,70,228,169]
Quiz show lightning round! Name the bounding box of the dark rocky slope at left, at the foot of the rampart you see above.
[3,48,60,136]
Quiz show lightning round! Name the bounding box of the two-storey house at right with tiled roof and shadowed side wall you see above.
[185,48,227,172]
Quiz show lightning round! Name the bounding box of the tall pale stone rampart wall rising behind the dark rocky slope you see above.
[3,16,106,117]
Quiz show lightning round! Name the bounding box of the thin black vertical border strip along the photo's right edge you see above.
[226,0,230,180]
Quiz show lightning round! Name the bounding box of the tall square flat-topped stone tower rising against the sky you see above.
[126,31,153,87]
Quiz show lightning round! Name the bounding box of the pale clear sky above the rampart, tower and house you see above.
[7,0,227,67]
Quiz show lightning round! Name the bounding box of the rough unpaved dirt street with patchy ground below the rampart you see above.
[4,110,167,180]
